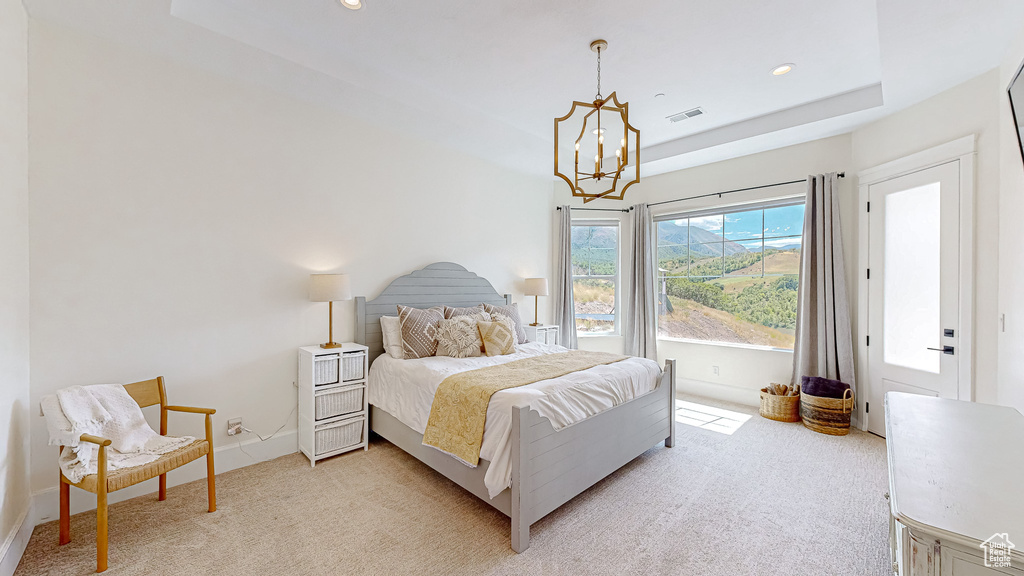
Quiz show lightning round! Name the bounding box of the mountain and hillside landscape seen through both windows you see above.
[572,204,804,342]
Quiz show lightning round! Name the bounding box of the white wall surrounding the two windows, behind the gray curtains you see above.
[555,135,856,405]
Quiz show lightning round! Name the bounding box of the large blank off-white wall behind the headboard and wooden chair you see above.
[30,22,553,498]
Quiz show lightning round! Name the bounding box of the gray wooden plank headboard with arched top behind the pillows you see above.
[355,262,512,362]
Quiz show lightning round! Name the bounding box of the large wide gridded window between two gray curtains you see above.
[656,200,804,349]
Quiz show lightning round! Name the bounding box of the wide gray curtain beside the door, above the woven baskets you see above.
[793,172,857,393]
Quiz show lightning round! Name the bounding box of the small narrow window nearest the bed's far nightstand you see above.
[572,220,618,334]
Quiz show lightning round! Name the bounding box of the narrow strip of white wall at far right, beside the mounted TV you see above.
[995,29,1024,412]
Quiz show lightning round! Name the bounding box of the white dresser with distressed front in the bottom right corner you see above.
[886,392,1024,576]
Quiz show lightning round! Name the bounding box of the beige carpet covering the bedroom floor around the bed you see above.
[16,399,889,576]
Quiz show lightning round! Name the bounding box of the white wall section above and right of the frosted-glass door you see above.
[844,70,999,403]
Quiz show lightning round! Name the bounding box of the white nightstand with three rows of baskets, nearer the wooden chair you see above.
[298,342,370,466]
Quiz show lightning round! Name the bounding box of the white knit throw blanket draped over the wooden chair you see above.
[39,384,196,484]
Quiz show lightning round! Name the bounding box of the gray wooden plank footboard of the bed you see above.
[509,360,676,552]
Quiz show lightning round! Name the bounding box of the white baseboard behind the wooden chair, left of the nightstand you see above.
[30,430,298,524]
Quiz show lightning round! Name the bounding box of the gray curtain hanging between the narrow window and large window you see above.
[626,204,657,361]
